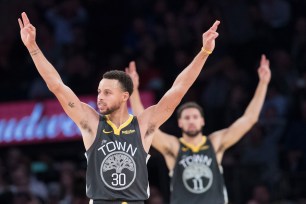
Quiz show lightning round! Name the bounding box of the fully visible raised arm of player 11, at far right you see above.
[210,55,271,161]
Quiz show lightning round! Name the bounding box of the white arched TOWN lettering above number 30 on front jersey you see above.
[98,141,137,156]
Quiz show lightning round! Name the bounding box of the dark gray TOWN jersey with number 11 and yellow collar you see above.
[170,136,227,204]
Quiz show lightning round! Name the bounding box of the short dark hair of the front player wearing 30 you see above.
[103,70,134,95]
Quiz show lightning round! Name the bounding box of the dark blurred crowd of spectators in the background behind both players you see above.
[0,0,306,204]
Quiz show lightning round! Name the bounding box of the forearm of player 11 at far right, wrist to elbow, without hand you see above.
[244,81,268,122]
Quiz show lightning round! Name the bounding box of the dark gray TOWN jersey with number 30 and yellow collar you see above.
[85,115,149,201]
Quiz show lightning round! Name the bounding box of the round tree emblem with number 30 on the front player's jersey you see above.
[100,151,136,190]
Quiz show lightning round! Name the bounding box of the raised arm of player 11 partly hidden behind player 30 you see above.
[125,61,179,166]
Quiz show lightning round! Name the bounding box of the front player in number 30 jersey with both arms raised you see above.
[18,13,220,204]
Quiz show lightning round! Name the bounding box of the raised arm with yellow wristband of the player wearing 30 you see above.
[138,21,220,151]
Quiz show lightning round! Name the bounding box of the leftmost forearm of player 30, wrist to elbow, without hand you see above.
[27,44,62,91]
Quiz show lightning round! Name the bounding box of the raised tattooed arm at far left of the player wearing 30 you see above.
[18,12,99,149]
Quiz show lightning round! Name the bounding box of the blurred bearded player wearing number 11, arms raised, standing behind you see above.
[126,55,271,204]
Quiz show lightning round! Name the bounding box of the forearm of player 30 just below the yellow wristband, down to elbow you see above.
[173,50,208,95]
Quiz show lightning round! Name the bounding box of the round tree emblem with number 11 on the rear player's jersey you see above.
[182,163,213,194]
